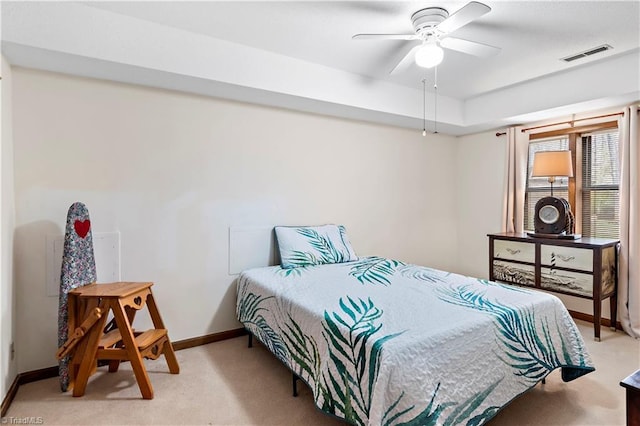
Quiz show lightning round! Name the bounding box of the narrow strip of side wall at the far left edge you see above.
[0,56,17,399]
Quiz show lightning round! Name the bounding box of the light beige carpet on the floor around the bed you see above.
[2,321,640,426]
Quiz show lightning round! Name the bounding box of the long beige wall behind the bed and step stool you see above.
[13,68,459,371]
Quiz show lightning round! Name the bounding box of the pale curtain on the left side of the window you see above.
[502,127,529,233]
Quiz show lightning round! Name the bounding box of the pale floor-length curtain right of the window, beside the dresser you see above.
[618,105,640,338]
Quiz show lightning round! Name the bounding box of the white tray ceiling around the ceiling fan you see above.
[2,1,640,134]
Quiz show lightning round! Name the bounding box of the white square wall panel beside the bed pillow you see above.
[229,226,276,275]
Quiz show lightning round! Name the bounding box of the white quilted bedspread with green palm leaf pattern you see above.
[236,257,594,425]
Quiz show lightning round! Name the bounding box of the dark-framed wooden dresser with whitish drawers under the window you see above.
[488,233,619,341]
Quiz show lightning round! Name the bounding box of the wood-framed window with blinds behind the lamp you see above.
[524,128,620,239]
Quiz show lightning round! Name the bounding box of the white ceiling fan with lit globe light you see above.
[352,1,500,74]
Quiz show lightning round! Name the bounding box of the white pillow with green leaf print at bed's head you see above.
[276,225,358,269]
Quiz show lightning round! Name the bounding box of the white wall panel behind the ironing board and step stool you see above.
[47,232,120,297]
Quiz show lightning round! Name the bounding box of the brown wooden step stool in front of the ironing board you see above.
[56,282,180,399]
